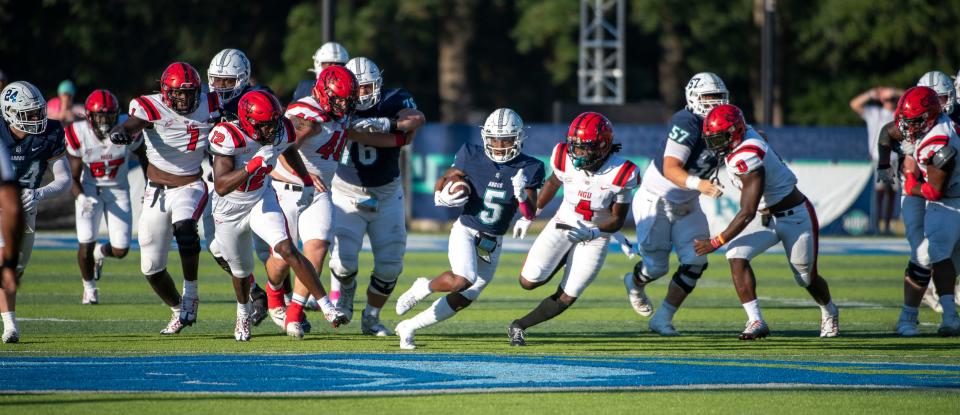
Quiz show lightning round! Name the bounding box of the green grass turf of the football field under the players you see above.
[0,250,960,413]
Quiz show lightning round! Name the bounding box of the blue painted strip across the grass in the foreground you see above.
[0,354,960,395]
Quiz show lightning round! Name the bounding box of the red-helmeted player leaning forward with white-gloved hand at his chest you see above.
[210,91,345,341]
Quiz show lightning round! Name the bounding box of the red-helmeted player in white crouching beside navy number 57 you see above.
[694,104,840,340]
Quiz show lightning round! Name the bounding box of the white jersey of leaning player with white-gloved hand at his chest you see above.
[210,119,296,206]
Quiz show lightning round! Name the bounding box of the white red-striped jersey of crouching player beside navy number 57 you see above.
[725,128,797,209]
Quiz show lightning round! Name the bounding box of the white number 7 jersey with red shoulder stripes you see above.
[129,93,220,176]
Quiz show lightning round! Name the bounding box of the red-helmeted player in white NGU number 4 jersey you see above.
[508,112,639,346]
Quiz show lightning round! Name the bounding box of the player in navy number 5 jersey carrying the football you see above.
[396,108,544,350]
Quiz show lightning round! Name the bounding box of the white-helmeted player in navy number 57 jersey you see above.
[623,72,729,336]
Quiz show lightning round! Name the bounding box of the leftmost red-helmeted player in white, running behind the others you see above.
[65,89,147,304]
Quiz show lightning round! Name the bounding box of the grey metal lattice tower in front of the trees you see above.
[577,0,626,105]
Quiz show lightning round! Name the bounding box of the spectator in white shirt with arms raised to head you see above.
[850,86,903,234]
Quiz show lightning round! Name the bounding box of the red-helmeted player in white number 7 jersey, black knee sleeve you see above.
[110,62,220,334]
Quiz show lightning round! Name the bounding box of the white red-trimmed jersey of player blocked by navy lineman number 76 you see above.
[277,97,349,185]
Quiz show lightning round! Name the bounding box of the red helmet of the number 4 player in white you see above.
[567,112,613,170]
